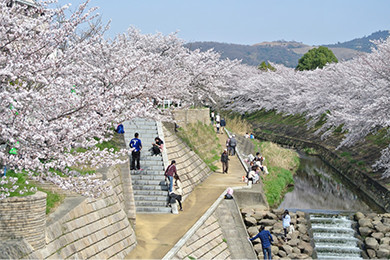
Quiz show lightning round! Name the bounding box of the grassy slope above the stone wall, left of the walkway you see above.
[177,122,222,171]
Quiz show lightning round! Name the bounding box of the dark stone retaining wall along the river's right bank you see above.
[256,132,390,212]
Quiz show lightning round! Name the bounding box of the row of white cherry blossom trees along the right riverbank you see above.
[227,39,390,177]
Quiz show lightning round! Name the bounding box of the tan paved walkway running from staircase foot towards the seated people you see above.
[126,131,246,259]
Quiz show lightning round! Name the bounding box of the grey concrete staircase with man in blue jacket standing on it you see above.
[123,118,171,213]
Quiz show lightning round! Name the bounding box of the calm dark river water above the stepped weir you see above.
[279,153,377,212]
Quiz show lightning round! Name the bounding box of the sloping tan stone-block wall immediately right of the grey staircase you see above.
[163,126,211,198]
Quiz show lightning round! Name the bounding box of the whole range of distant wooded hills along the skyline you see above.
[186,31,390,68]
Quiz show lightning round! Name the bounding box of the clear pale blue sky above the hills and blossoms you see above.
[59,0,390,45]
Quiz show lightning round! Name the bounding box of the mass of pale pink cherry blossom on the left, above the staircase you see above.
[0,0,241,197]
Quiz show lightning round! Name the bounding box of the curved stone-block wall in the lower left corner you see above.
[0,191,46,250]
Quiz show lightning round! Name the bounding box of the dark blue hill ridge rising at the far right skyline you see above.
[323,30,390,52]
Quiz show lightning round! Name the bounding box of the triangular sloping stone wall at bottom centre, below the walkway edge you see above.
[173,212,231,259]
